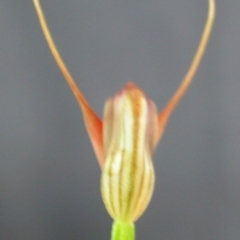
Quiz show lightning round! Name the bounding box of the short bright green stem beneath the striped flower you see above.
[111,221,135,240]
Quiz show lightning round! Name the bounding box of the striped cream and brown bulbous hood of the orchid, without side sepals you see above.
[101,83,158,221]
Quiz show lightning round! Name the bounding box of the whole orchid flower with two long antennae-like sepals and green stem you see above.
[33,0,215,240]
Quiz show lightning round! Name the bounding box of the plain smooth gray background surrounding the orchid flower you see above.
[0,0,240,240]
